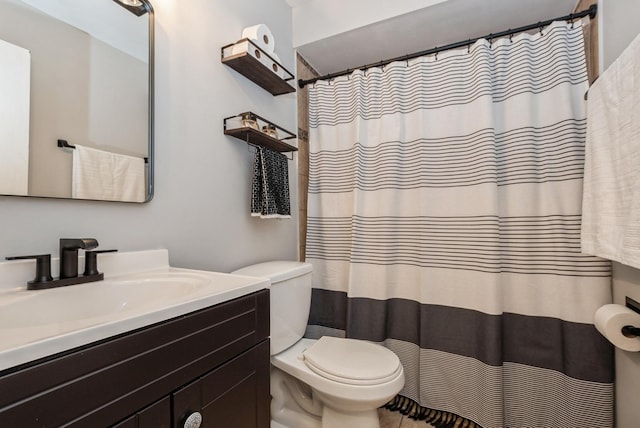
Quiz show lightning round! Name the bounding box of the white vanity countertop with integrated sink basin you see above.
[0,250,270,372]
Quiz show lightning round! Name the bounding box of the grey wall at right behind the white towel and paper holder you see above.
[598,0,640,428]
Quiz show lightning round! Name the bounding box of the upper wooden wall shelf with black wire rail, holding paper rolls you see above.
[221,39,296,95]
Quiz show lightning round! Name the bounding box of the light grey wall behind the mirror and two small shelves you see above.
[0,0,298,271]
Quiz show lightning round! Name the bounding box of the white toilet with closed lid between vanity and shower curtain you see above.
[233,261,404,428]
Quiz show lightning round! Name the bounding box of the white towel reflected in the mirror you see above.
[71,145,145,202]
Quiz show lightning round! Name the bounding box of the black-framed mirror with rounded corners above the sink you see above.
[0,0,154,202]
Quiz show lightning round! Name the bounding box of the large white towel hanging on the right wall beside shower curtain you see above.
[581,32,640,268]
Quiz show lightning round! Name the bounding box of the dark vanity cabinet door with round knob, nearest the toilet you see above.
[173,340,271,428]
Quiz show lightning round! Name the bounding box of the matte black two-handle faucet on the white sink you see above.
[7,238,117,290]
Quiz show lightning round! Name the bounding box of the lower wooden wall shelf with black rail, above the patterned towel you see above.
[223,111,298,152]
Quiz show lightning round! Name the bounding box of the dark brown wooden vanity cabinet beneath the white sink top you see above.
[0,290,270,428]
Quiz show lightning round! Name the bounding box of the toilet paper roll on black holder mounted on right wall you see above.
[594,304,640,352]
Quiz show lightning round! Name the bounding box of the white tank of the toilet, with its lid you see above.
[232,261,311,355]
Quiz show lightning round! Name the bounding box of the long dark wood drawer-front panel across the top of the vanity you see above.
[0,290,269,428]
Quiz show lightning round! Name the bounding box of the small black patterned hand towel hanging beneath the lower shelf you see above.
[251,147,291,218]
